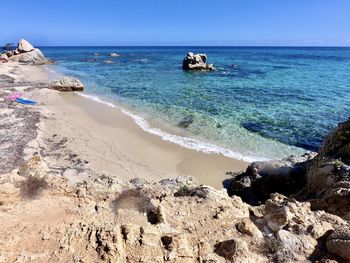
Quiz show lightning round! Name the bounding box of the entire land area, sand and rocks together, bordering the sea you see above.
[0,40,350,263]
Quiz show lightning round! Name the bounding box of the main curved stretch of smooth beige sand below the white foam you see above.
[40,93,247,189]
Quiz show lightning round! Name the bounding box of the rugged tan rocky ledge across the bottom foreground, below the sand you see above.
[0,156,349,263]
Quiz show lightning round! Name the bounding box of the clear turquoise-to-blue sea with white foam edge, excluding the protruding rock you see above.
[42,47,350,161]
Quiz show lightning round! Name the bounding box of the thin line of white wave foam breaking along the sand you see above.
[76,92,270,162]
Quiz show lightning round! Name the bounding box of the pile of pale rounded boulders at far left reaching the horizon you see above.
[1,39,53,65]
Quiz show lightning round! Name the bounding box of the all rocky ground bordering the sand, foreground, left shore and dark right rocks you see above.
[0,39,350,263]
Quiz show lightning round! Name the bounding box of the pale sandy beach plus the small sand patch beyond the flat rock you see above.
[0,63,247,189]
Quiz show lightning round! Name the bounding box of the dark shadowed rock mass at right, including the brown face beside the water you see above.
[230,119,350,220]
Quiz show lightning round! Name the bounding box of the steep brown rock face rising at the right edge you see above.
[304,119,350,220]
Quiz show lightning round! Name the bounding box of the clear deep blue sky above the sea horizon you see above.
[0,0,350,46]
